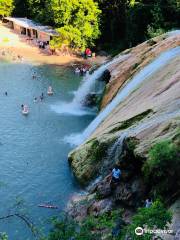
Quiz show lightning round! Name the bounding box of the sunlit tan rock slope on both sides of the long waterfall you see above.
[69,32,180,186]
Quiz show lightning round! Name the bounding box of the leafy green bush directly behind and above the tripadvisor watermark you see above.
[119,200,172,240]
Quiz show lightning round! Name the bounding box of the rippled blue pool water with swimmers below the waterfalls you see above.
[0,62,94,240]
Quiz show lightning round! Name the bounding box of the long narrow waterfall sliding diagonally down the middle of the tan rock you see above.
[65,47,180,145]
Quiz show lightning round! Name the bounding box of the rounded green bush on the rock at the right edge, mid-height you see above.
[142,141,180,180]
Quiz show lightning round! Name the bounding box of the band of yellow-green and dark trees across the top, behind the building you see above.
[9,0,180,52]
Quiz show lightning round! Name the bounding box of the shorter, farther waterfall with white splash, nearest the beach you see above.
[51,54,129,116]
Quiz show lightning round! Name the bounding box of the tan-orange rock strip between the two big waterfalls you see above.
[101,33,180,108]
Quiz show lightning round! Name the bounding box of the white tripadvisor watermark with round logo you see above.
[135,227,173,236]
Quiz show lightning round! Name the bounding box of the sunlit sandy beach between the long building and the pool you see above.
[0,23,106,65]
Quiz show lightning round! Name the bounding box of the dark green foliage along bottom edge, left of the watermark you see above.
[44,211,120,240]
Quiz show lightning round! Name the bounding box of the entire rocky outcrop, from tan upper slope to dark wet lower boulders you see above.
[69,31,180,223]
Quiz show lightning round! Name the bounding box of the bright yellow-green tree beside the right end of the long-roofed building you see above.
[49,0,101,49]
